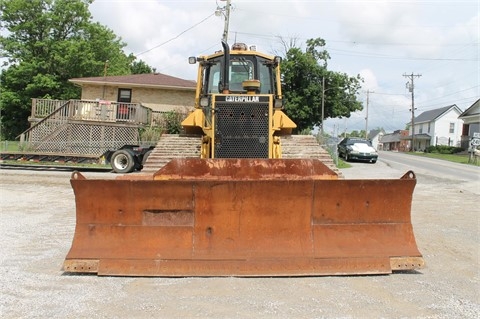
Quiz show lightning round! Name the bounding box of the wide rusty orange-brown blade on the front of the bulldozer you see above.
[63,159,424,276]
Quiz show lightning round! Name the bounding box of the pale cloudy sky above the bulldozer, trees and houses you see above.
[90,0,480,135]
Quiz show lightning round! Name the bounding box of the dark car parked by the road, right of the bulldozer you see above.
[338,137,378,163]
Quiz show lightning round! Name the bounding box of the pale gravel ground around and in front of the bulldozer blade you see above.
[0,162,480,318]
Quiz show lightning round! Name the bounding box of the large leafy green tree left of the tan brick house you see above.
[0,0,149,139]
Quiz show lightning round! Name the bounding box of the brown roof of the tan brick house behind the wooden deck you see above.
[69,73,196,90]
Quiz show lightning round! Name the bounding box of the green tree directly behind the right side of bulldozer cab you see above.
[282,38,363,131]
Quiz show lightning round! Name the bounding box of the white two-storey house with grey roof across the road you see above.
[408,104,463,151]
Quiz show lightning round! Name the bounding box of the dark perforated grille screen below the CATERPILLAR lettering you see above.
[213,102,269,158]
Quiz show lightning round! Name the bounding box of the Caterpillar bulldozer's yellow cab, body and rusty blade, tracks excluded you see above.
[63,42,424,277]
